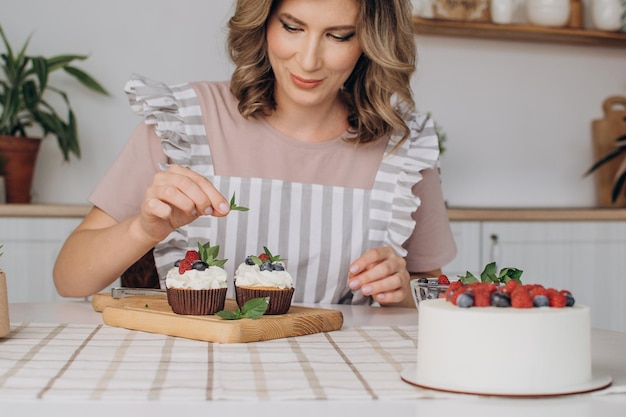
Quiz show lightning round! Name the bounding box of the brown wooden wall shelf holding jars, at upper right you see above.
[413,16,626,48]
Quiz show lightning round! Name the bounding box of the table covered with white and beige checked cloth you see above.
[0,302,626,417]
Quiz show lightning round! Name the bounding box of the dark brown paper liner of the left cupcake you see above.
[167,288,227,316]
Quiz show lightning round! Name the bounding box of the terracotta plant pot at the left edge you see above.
[0,135,41,204]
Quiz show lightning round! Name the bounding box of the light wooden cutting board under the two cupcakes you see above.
[92,293,343,343]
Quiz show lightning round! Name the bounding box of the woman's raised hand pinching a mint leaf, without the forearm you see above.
[140,165,230,241]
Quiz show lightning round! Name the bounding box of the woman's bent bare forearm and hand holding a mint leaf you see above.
[53,165,229,297]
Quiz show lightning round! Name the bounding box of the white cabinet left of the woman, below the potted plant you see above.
[0,217,81,303]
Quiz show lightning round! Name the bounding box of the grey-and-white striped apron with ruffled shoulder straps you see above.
[126,75,439,304]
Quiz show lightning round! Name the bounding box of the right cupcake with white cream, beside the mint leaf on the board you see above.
[234,246,294,314]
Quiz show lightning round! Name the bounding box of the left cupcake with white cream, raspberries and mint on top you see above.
[165,242,228,316]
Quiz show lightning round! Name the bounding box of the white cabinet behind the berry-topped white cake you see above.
[446,221,626,332]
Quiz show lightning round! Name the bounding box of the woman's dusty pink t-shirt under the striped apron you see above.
[89,82,456,272]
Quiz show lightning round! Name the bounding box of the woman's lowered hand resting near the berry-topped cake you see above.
[348,246,414,307]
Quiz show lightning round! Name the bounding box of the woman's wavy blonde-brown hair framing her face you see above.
[228,0,416,143]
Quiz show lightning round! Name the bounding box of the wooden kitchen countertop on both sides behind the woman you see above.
[0,204,626,221]
